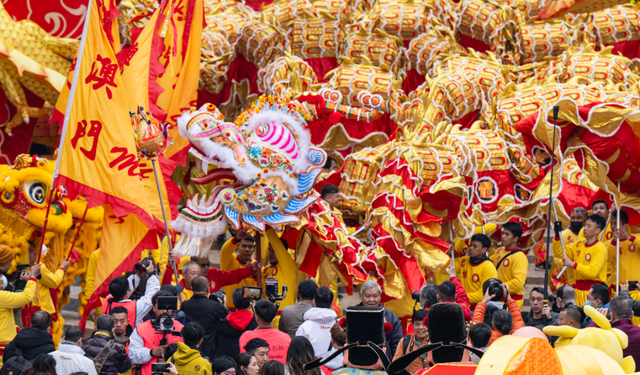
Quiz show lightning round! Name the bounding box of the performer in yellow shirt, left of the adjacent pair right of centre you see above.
[456,233,498,311]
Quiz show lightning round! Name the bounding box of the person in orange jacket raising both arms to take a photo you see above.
[473,279,524,345]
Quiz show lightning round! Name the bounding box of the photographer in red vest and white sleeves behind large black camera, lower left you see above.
[129,290,182,375]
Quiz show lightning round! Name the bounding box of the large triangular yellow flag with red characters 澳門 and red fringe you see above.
[58,0,155,229]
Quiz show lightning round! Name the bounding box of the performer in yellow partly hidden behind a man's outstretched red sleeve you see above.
[220,228,258,311]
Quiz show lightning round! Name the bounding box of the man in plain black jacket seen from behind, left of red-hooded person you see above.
[180,276,227,359]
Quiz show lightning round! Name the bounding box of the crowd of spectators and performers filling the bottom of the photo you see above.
[0,173,640,375]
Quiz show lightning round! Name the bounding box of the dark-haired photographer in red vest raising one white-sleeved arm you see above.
[102,260,160,328]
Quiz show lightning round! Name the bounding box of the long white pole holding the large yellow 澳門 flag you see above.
[36,0,93,264]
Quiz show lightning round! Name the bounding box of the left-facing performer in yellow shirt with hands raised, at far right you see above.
[553,215,607,306]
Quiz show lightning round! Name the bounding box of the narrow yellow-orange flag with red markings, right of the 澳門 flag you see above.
[157,0,203,165]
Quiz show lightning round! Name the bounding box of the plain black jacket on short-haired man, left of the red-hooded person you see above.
[180,294,227,360]
